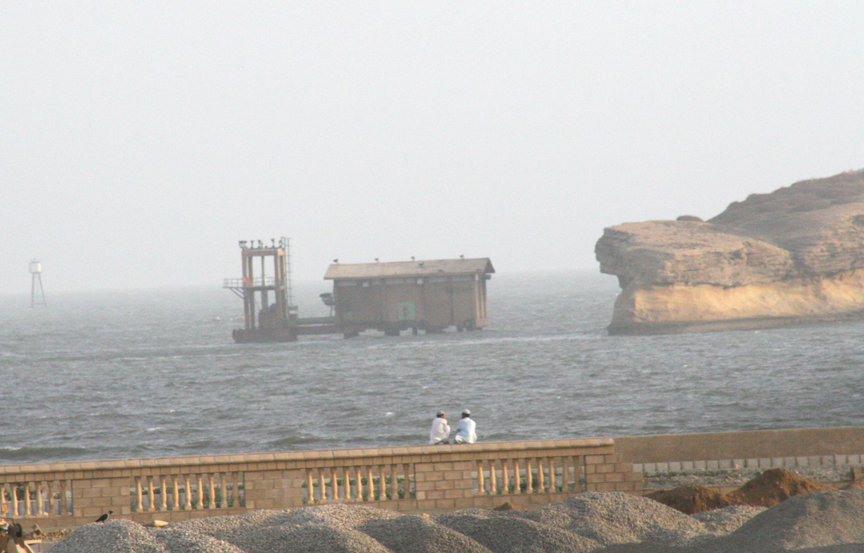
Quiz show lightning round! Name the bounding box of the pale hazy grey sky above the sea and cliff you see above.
[0,0,864,296]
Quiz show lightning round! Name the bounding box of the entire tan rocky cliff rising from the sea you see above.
[595,170,864,334]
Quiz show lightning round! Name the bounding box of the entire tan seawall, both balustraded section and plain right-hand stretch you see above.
[0,427,864,531]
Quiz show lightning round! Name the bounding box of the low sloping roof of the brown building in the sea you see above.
[324,257,495,280]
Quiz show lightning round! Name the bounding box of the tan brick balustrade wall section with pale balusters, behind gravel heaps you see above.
[0,438,642,530]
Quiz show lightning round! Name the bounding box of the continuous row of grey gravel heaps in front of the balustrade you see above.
[48,490,864,553]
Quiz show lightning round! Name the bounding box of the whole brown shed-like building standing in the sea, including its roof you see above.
[324,257,495,337]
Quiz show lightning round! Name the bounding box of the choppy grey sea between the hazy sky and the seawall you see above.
[0,272,864,463]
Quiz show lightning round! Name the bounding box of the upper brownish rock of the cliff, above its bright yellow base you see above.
[595,170,864,288]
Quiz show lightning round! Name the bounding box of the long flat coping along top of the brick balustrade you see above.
[0,438,615,475]
